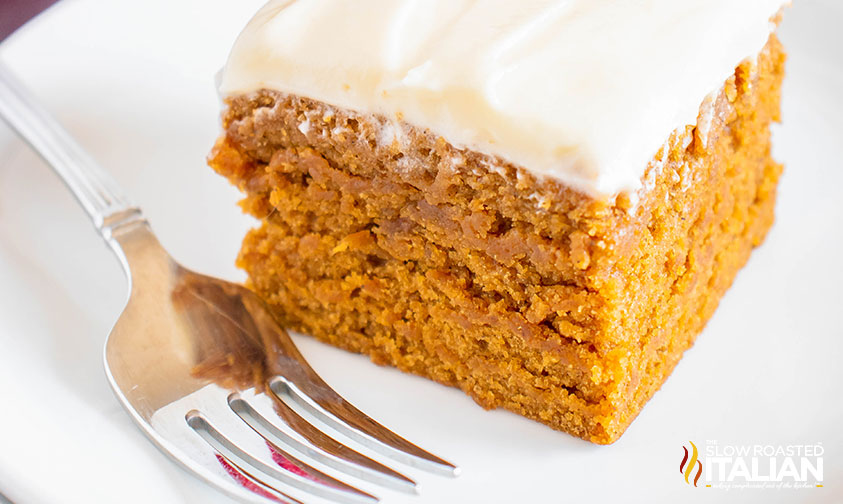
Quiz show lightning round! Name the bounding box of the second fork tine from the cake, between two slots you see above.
[228,392,418,494]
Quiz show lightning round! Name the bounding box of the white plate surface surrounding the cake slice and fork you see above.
[0,0,843,504]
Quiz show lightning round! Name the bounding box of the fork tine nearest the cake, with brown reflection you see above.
[269,378,460,477]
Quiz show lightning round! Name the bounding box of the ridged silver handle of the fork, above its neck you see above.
[0,63,143,235]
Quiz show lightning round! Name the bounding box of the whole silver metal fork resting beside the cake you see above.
[0,64,459,503]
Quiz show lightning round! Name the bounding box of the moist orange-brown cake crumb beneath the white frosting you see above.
[209,0,784,444]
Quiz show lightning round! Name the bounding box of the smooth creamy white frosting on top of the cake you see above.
[220,0,785,197]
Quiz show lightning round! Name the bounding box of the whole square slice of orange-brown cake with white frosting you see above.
[210,0,784,443]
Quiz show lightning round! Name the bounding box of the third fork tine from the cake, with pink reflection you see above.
[190,410,378,504]
